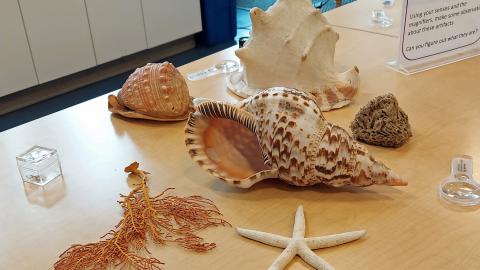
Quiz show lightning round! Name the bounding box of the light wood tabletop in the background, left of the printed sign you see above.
[324,0,403,37]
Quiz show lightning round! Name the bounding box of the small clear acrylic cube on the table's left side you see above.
[17,145,62,186]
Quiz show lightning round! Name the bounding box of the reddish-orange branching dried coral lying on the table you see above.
[54,162,230,270]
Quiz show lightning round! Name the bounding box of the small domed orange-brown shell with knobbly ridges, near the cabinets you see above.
[108,62,193,121]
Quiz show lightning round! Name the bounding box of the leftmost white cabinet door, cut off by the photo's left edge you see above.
[0,0,38,96]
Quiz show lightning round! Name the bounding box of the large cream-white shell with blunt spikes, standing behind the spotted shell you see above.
[227,0,359,111]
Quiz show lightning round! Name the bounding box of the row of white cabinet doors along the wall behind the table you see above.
[0,0,202,97]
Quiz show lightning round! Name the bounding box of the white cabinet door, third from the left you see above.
[86,0,147,64]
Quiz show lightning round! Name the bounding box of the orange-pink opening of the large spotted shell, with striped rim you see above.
[186,113,270,184]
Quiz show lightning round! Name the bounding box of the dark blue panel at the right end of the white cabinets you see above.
[200,0,237,46]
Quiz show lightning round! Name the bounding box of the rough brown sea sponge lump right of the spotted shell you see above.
[350,94,412,147]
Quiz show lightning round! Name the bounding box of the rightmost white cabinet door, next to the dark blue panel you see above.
[142,0,202,48]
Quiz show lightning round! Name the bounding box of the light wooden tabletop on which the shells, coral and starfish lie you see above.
[0,23,480,270]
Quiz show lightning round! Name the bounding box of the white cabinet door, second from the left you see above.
[19,0,96,83]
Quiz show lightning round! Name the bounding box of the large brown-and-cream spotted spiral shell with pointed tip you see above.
[185,87,407,188]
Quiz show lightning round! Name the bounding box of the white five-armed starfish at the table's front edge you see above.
[237,205,367,270]
